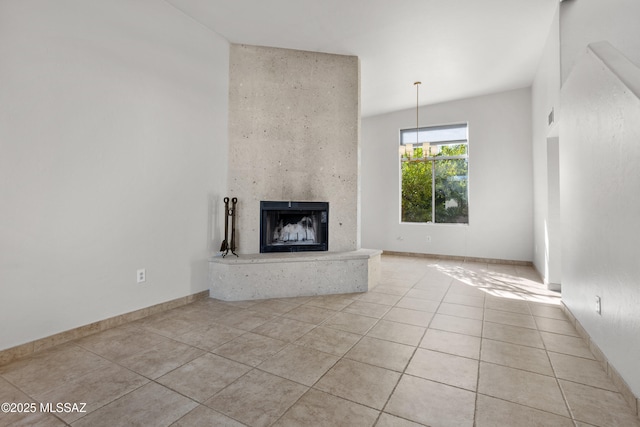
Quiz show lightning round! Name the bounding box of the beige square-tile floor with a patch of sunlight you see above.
[0,255,640,427]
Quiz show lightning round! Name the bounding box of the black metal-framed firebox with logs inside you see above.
[260,201,329,252]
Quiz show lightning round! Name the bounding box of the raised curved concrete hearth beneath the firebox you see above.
[209,249,382,301]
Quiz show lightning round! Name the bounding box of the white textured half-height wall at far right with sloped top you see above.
[560,44,640,396]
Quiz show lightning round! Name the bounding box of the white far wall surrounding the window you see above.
[361,88,533,261]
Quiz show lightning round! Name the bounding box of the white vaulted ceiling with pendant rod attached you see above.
[168,0,558,117]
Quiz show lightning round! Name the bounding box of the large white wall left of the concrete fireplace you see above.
[0,0,228,349]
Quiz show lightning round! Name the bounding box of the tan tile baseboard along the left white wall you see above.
[0,290,209,366]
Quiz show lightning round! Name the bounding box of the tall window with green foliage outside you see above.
[400,123,469,224]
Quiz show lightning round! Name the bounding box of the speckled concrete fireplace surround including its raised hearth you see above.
[209,45,381,301]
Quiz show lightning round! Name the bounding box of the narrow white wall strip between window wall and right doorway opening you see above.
[531,6,562,285]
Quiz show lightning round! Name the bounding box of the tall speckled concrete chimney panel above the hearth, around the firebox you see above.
[229,45,360,254]
